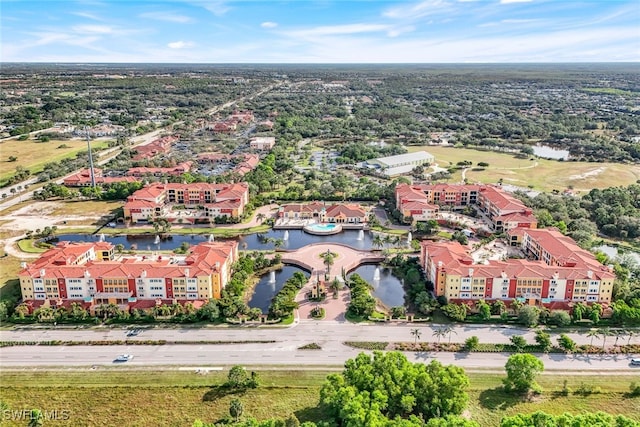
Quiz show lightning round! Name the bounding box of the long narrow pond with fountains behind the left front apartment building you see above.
[52,230,373,251]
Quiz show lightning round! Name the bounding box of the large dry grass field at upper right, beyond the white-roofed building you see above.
[408,146,640,195]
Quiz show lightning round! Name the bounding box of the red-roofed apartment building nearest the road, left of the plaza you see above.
[18,241,238,306]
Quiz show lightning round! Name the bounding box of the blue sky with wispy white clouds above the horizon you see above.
[0,0,640,63]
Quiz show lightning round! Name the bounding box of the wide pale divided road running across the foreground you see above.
[0,320,640,374]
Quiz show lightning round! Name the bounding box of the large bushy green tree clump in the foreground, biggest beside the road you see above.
[320,351,469,427]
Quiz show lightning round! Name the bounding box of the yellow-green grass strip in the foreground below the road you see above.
[0,369,640,427]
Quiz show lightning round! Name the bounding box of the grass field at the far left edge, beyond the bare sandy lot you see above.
[0,139,107,183]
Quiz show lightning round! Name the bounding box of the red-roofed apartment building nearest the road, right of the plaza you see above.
[420,237,615,308]
